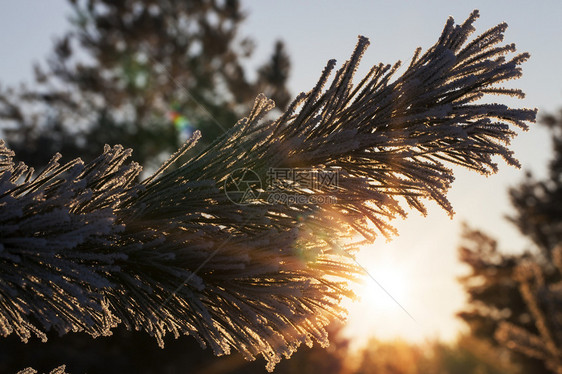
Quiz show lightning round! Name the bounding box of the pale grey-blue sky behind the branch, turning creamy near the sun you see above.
[0,0,562,340]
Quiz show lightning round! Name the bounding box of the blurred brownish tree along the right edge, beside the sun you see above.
[459,111,562,373]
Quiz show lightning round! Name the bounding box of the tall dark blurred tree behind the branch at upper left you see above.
[0,0,290,166]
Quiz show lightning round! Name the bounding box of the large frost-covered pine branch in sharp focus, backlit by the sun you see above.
[0,12,536,369]
